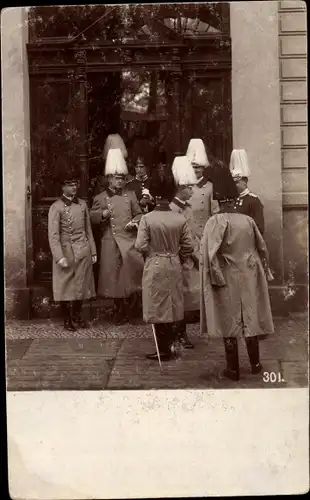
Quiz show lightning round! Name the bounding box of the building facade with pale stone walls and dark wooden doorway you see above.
[2,1,308,318]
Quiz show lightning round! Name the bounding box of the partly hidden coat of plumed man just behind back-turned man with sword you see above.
[170,197,200,312]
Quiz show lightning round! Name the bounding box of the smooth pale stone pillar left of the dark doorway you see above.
[1,7,31,317]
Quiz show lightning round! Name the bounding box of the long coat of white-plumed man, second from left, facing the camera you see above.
[90,188,144,298]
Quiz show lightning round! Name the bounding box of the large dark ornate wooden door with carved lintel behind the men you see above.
[28,2,231,288]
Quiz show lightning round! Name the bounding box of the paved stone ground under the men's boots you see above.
[6,316,308,391]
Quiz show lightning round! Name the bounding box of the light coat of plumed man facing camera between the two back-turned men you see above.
[189,177,219,239]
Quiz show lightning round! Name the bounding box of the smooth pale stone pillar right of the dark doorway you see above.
[230,1,283,311]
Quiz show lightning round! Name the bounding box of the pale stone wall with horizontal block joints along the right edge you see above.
[278,0,308,310]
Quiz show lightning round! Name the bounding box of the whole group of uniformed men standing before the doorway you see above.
[48,134,273,380]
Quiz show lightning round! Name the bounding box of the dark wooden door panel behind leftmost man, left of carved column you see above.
[30,78,75,283]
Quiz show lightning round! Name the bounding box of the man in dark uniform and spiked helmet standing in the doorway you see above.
[127,156,155,213]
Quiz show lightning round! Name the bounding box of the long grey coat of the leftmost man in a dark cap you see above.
[48,196,96,301]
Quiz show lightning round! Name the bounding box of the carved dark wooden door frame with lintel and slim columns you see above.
[27,17,231,292]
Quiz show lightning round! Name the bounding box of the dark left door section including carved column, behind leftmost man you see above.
[30,73,88,286]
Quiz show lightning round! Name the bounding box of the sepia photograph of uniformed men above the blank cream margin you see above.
[1,0,309,499]
